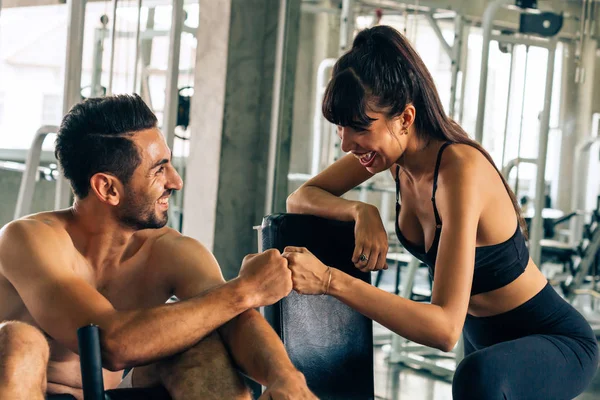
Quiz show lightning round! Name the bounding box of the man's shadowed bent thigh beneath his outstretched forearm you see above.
[132,332,252,400]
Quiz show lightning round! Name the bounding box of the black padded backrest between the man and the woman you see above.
[262,214,374,400]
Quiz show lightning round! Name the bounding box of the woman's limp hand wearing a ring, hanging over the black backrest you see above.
[352,203,388,272]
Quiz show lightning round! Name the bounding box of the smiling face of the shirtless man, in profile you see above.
[117,128,183,230]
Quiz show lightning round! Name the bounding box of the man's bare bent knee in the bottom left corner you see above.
[0,321,50,400]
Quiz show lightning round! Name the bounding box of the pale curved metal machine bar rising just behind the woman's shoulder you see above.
[475,0,513,143]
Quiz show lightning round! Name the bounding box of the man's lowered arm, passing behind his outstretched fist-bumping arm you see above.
[161,236,304,386]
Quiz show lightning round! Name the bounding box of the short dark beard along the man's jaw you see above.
[118,191,169,231]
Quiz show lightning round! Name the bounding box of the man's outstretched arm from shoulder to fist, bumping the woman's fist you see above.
[0,220,291,370]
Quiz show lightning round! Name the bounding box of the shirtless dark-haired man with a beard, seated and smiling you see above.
[0,95,315,400]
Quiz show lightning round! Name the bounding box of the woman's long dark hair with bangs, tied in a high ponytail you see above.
[323,25,526,234]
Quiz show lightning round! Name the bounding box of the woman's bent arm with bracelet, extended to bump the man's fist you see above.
[287,155,486,351]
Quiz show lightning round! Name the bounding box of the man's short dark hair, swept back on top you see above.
[54,95,157,199]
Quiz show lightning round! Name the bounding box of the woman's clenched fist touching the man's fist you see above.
[282,246,331,294]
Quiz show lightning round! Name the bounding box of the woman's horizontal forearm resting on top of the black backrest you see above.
[287,186,367,221]
